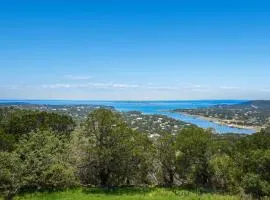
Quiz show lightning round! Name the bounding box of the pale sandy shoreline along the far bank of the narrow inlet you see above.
[175,112,263,132]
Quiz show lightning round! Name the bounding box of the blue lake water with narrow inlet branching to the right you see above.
[0,100,255,134]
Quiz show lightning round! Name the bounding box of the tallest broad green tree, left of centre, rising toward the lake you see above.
[81,109,154,187]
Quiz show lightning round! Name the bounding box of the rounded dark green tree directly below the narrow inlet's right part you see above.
[176,127,212,186]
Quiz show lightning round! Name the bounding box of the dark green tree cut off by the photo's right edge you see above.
[235,128,270,198]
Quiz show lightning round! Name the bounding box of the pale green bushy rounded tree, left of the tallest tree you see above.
[16,131,75,189]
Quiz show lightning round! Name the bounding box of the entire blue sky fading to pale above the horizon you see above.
[0,0,270,100]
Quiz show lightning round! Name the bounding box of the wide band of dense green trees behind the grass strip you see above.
[0,109,270,199]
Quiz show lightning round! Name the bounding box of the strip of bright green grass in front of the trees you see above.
[8,188,240,200]
